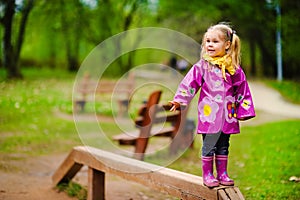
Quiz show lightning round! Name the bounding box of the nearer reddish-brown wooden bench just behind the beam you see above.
[113,91,194,160]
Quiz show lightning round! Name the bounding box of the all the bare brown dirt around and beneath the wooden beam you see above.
[0,154,173,200]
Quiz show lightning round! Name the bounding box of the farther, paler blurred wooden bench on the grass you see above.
[73,73,135,116]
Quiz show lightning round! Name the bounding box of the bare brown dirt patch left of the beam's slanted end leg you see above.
[0,155,74,200]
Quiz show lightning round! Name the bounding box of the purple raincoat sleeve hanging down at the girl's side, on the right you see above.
[233,67,255,120]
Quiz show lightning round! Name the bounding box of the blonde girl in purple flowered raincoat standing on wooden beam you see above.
[170,23,255,187]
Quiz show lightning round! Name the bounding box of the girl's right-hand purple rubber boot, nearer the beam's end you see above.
[216,155,234,186]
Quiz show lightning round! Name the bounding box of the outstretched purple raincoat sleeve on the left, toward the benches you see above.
[173,62,203,105]
